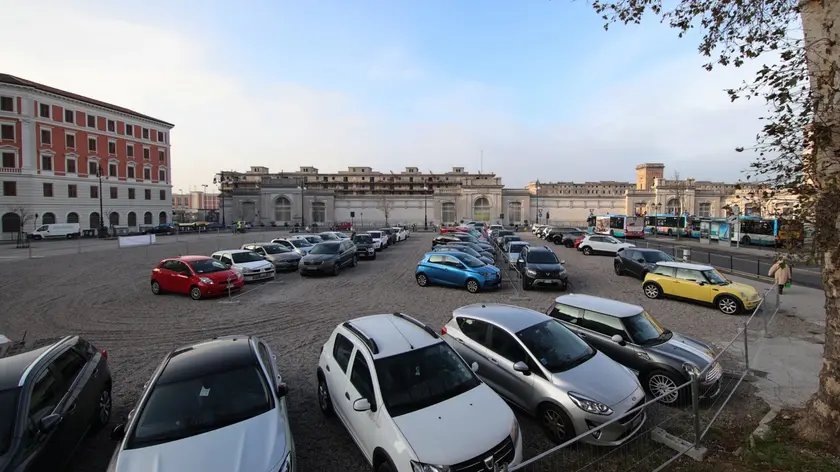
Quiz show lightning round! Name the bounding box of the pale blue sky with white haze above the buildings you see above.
[0,0,763,189]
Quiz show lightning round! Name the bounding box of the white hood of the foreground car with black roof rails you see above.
[394,383,515,465]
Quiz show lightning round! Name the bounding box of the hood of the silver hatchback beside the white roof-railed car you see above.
[551,351,639,407]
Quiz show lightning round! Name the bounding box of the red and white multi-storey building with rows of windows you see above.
[0,74,174,239]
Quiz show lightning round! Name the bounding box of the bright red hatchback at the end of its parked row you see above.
[152,256,245,300]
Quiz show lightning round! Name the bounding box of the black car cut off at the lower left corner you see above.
[0,336,111,472]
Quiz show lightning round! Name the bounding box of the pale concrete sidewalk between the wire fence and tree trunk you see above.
[730,276,825,408]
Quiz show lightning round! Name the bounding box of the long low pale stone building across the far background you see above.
[216,163,793,226]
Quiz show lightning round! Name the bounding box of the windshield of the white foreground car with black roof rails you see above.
[375,342,481,417]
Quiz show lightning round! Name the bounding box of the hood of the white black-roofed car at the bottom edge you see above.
[114,409,288,472]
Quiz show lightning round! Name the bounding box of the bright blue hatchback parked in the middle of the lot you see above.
[414,251,502,293]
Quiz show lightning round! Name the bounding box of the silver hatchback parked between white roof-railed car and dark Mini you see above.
[441,303,646,446]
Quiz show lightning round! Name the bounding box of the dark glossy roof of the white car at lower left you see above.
[157,336,257,384]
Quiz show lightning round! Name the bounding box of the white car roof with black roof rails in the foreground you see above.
[349,314,441,359]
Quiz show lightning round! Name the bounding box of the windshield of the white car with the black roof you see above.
[128,364,273,449]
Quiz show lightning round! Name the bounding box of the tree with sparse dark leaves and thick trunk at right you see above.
[593,0,840,444]
